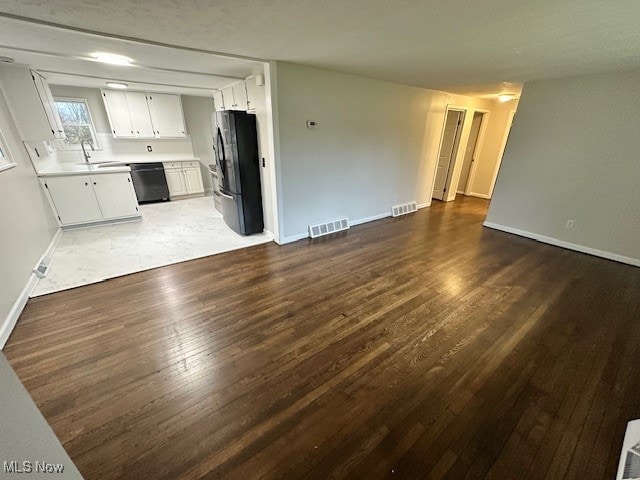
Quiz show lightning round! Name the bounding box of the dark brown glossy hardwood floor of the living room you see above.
[5,198,640,480]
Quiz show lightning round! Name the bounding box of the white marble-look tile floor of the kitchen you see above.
[31,197,271,297]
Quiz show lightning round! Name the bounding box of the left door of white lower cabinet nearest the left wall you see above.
[44,175,102,225]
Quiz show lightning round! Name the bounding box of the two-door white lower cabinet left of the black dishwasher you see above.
[41,172,140,226]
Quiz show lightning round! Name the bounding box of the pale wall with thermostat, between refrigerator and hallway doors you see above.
[276,62,504,242]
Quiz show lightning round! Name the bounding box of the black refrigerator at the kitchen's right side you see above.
[214,110,264,235]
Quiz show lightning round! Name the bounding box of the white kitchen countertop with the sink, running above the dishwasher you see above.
[38,155,200,177]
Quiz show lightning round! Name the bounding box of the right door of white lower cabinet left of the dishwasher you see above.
[90,173,139,220]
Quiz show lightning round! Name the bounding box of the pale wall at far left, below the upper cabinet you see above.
[0,92,58,347]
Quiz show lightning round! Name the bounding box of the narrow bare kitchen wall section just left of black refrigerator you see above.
[182,95,215,192]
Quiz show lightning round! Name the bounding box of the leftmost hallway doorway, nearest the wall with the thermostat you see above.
[432,109,466,200]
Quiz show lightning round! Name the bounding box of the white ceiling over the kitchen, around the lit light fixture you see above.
[0,16,261,96]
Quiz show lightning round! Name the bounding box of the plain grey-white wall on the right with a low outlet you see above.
[487,72,640,265]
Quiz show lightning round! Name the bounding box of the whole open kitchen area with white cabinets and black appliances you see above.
[0,16,273,296]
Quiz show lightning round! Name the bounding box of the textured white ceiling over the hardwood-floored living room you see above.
[0,0,640,94]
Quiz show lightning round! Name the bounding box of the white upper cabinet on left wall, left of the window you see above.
[0,64,65,141]
